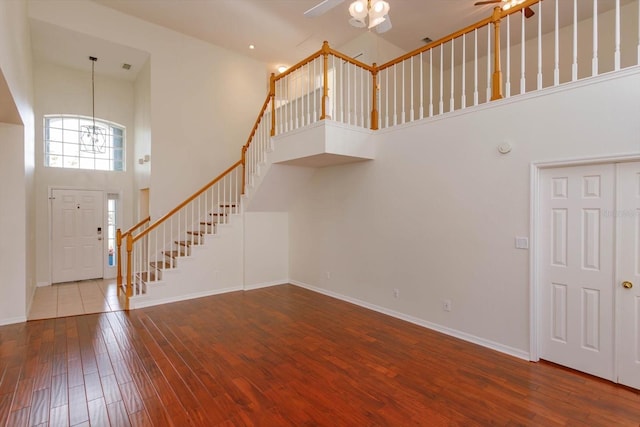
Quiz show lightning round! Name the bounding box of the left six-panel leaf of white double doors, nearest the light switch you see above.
[539,164,615,380]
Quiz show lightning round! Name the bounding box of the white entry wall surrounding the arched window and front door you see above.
[34,62,137,285]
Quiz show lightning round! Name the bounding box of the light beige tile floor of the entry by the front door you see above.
[28,279,125,320]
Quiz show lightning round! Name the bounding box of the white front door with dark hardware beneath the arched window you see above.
[51,189,105,283]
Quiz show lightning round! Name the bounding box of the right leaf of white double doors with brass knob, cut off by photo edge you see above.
[615,163,640,389]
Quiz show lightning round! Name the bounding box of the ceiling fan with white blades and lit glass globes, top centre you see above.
[304,0,391,34]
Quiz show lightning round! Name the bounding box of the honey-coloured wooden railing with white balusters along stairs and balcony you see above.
[116,0,640,310]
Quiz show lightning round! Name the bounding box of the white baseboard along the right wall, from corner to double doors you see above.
[289,280,530,361]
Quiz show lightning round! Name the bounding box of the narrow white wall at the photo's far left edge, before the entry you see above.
[0,1,35,324]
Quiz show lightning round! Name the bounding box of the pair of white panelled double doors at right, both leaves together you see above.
[538,162,640,389]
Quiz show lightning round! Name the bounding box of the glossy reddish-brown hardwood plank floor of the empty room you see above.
[0,285,640,426]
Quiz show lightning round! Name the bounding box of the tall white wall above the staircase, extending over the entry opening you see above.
[29,0,267,218]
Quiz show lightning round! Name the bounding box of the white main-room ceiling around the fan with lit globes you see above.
[94,0,492,69]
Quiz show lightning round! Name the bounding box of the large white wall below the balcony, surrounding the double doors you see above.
[290,70,640,355]
